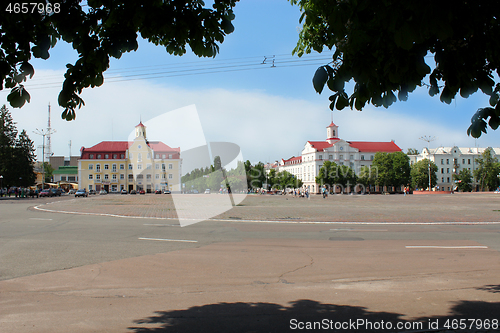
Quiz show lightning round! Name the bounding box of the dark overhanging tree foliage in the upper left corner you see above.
[0,0,237,120]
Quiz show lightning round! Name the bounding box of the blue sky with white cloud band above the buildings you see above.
[0,0,500,162]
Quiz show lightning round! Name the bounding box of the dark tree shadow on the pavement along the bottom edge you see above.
[129,300,500,333]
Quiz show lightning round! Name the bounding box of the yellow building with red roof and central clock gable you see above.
[78,122,182,193]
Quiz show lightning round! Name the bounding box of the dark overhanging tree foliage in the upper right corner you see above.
[290,0,500,138]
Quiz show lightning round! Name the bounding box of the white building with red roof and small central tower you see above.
[276,121,401,193]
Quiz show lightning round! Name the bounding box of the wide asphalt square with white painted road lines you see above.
[0,194,500,333]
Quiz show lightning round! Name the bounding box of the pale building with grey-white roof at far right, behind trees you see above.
[409,146,500,191]
